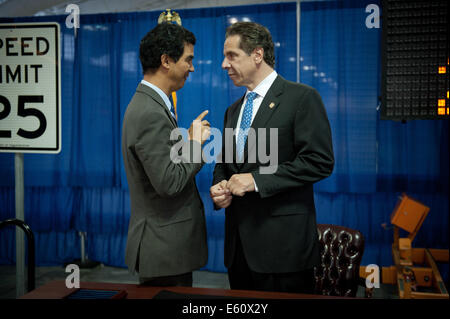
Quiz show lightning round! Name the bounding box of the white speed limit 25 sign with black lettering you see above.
[0,23,61,153]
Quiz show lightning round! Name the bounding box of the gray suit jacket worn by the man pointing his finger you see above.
[122,84,208,277]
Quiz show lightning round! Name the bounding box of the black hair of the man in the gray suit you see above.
[139,23,195,74]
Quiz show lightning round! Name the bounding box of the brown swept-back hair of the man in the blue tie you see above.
[225,22,275,68]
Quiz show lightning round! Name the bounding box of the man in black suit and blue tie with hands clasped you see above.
[210,22,334,293]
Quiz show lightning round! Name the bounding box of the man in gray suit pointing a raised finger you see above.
[122,23,210,286]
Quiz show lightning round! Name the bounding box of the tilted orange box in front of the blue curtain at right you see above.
[391,193,430,235]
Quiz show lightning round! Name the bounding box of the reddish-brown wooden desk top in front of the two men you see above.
[20,281,340,299]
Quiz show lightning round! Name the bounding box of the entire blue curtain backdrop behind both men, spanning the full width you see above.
[0,1,449,278]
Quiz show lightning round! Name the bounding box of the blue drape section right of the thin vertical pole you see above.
[300,1,449,277]
